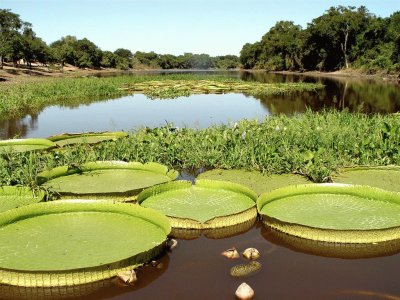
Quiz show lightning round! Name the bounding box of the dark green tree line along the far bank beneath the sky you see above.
[0,6,400,73]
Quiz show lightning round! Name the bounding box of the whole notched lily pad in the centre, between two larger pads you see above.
[138,180,257,229]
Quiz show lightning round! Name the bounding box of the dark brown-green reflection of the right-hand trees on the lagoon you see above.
[241,72,400,115]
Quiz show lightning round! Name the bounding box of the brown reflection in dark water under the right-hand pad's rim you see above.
[261,227,400,259]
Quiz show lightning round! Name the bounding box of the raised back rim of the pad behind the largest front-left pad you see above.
[36,160,178,185]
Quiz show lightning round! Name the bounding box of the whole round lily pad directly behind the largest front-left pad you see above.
[37,161,178,196]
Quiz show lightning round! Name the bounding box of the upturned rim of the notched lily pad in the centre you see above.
[137,179,257,230]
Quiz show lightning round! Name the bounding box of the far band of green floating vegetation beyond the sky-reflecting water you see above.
[0,74,322,118]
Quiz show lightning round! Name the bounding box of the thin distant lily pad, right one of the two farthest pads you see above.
[48,132,128,147]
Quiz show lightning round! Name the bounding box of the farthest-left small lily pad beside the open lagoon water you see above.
[0,139,57,152]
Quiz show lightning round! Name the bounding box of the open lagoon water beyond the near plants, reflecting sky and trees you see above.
[0,71,400,139]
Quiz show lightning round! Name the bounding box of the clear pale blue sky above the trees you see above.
[0,0,400,55]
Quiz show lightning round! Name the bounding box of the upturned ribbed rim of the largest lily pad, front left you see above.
[0,199,171,287]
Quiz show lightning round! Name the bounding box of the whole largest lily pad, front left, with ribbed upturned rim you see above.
[0,200,171,286]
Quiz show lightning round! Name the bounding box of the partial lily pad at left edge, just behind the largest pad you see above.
[0,186,44,213]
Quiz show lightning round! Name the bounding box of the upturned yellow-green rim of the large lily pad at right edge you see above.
[257,183,400,243]
